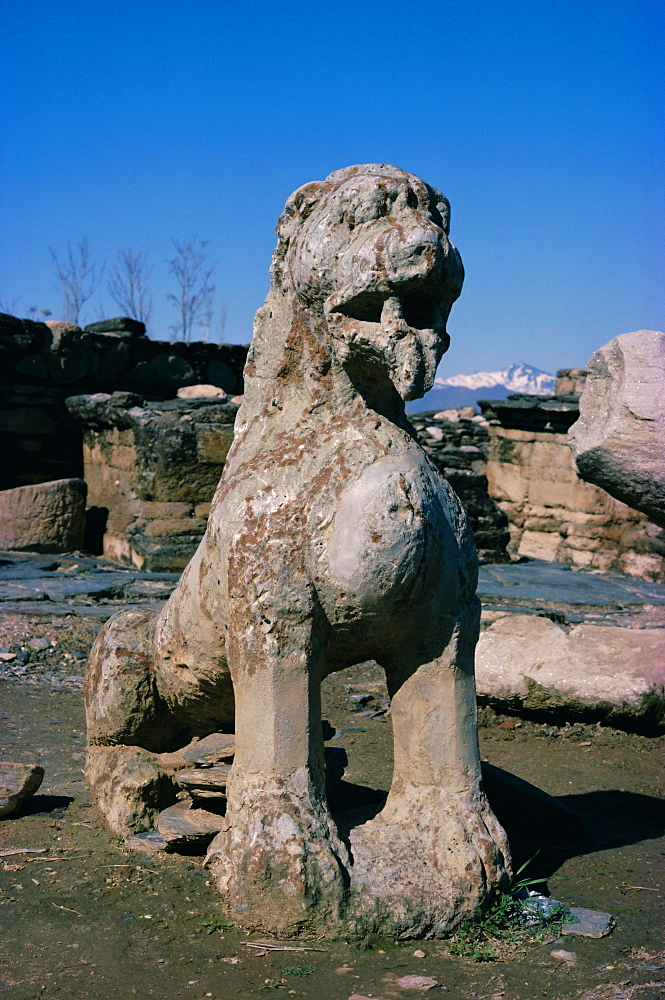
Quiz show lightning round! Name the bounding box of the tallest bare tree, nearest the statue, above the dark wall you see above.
[167,236,215,341]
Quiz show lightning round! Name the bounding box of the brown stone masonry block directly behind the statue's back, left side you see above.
[67,392,238,572]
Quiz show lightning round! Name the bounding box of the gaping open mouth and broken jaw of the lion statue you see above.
[324,292,450,400]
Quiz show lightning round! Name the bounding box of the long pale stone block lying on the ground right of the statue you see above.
[476,615,665,728]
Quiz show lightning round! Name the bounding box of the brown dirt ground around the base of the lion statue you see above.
[0,615,665,1000]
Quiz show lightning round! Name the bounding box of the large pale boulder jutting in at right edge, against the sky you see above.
[568,330,665,528]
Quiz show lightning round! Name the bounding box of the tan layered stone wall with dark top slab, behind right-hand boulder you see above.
[480,388,665,582]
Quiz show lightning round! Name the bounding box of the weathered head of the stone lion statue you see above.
[246,164,464,400]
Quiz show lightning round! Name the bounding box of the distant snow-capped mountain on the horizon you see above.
[406,363,556,413]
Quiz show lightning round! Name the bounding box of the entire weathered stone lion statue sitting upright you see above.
[86,164,509,937]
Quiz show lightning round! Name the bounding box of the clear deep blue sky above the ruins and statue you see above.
[0,0,665,375]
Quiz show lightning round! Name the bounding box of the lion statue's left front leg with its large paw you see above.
[208,602,348,934]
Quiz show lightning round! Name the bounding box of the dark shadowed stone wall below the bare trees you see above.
[0,314,247,490]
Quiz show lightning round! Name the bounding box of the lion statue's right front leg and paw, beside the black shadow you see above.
[350,606,510,937]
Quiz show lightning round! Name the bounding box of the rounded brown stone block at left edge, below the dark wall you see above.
[0,479,87,552]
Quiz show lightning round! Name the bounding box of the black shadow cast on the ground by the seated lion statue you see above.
[328,762,665,893]
